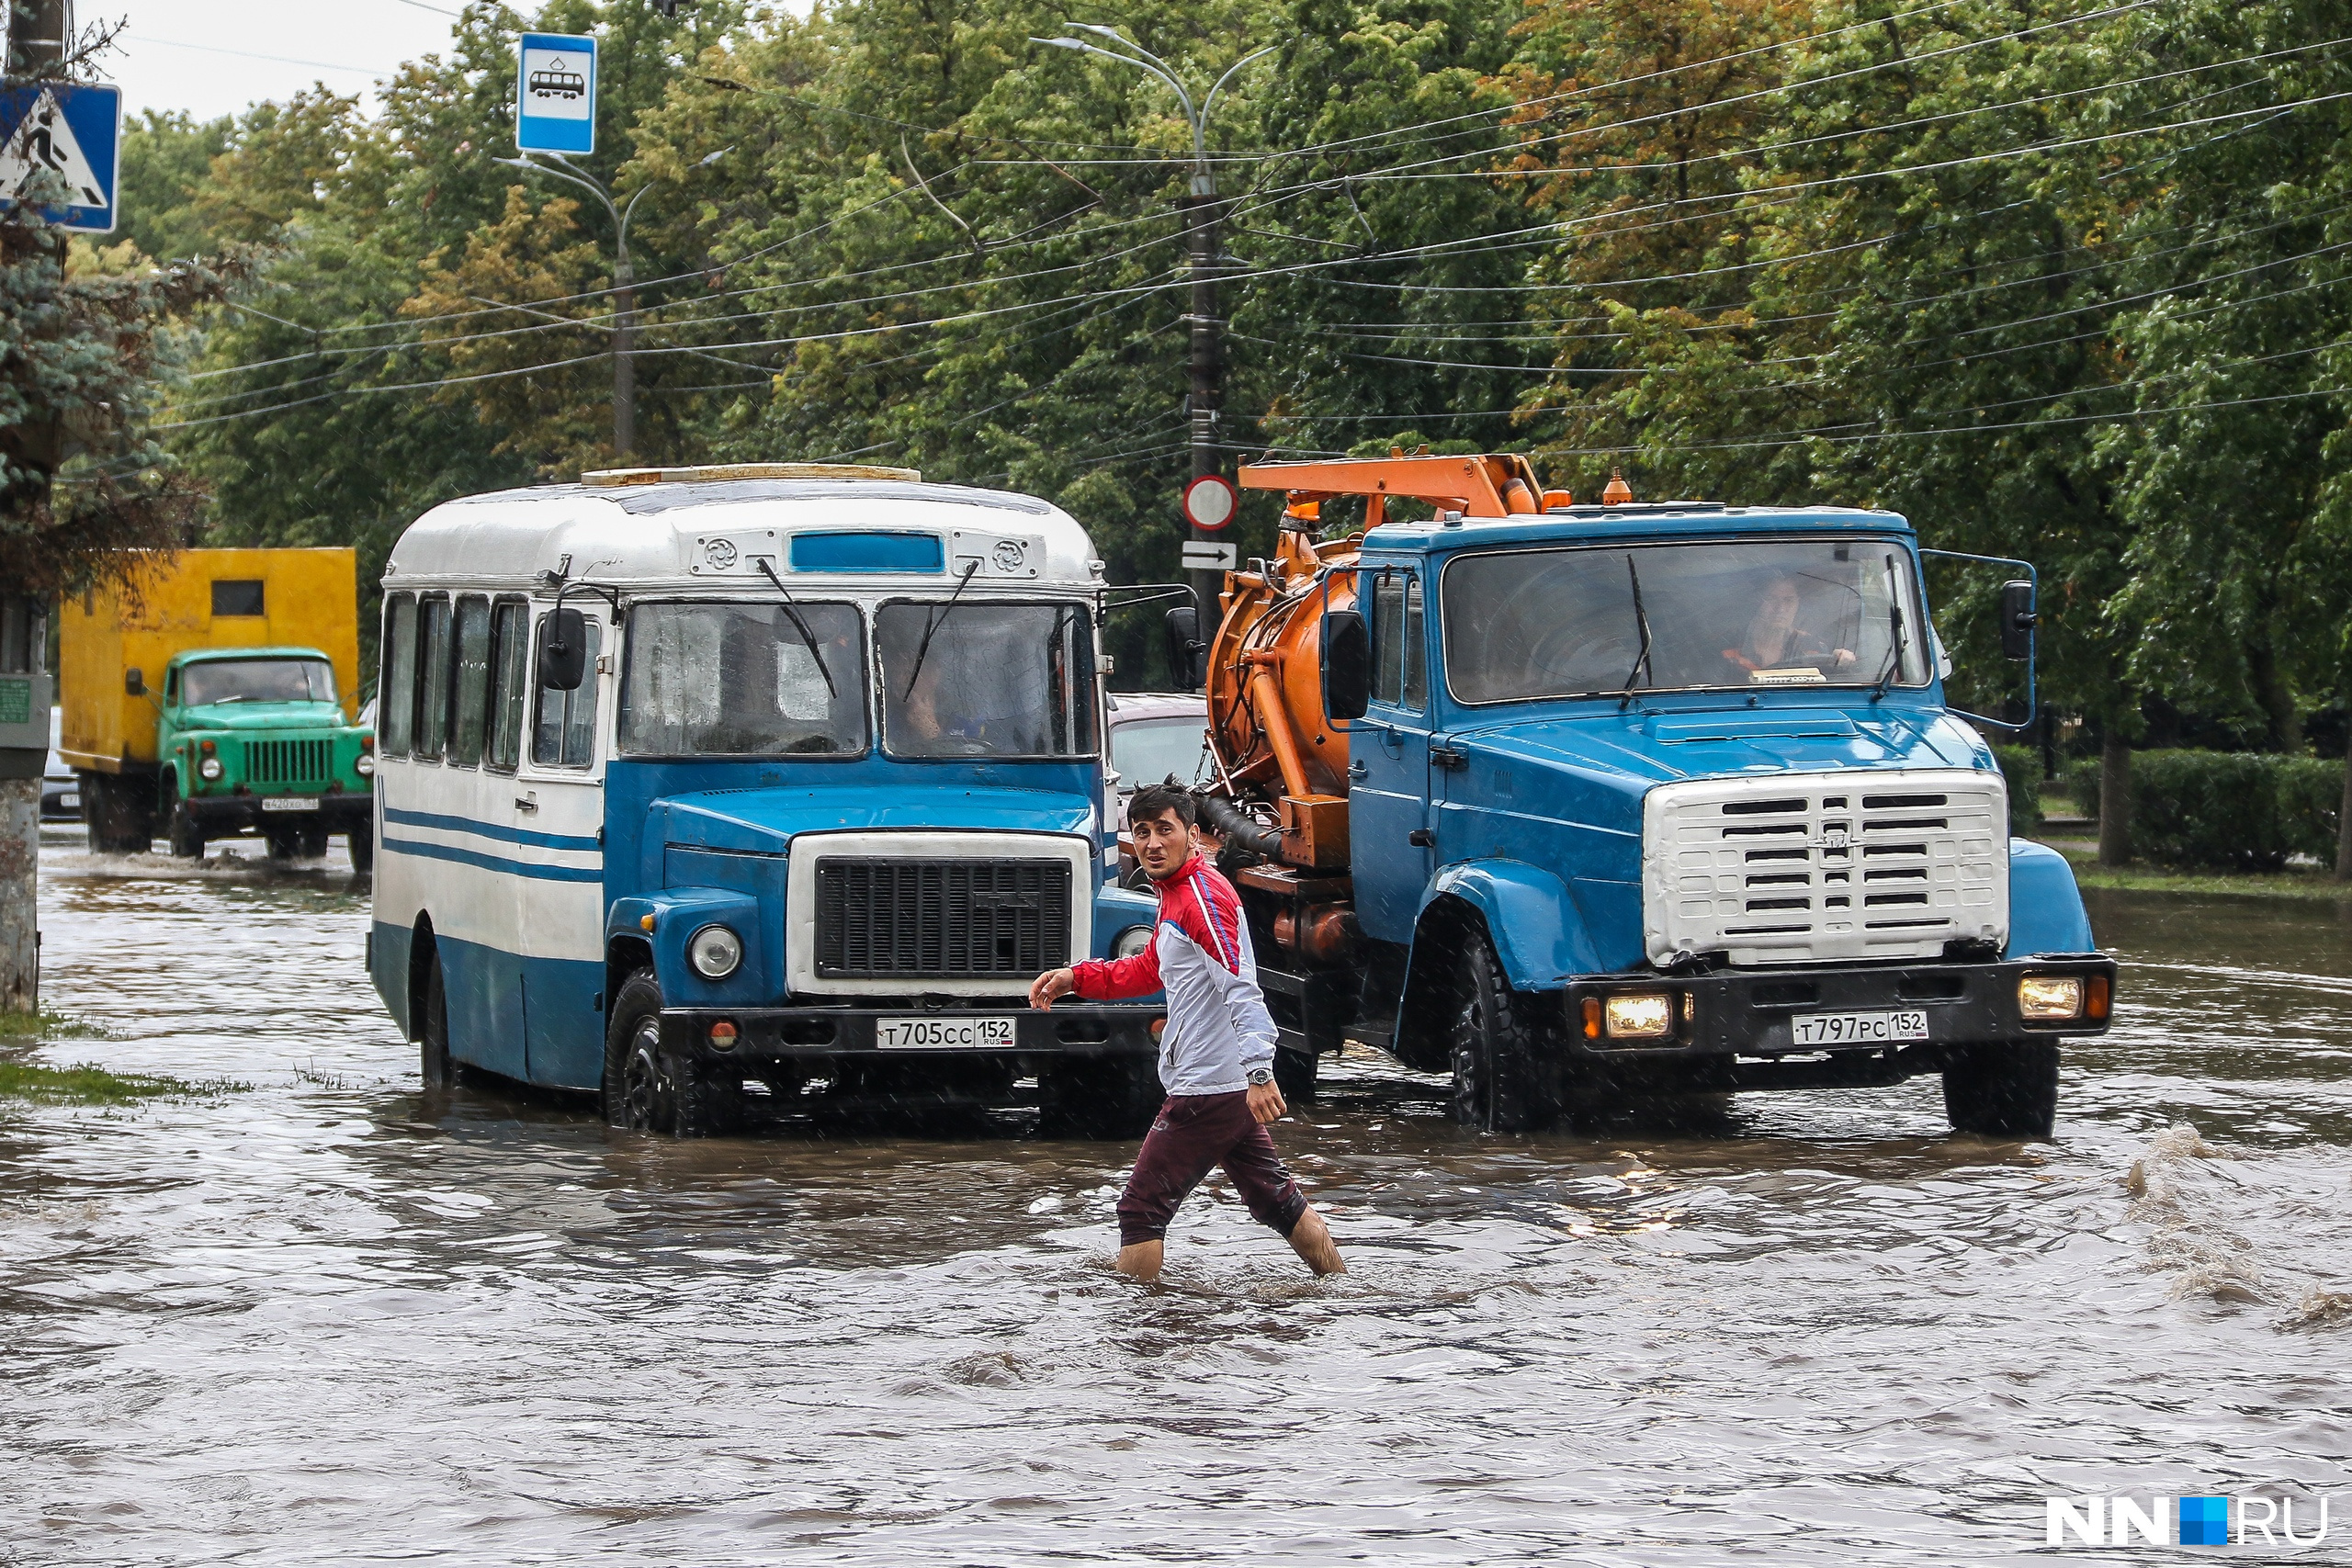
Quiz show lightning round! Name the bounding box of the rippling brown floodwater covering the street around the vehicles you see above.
[0,829,2352,1568]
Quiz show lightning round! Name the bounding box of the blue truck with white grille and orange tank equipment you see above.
[1169,456,2114,1138]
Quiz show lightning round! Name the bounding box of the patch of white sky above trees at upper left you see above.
[99,0,458,120]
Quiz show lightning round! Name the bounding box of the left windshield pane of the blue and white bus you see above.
[618,600,865,757]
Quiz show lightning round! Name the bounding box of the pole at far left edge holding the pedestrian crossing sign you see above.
[0,0,73,1013]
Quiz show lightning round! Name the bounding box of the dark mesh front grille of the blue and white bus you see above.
[816,856,1070,980]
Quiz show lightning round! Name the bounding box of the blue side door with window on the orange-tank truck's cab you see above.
[1348,567,1435,942]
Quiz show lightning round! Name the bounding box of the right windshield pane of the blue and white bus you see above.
[875,600,1099,757]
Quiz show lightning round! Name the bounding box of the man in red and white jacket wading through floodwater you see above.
[1030,785,1348,1279]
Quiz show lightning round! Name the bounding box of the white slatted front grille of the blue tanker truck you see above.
[1642,769,2008,964]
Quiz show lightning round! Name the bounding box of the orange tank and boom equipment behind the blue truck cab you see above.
[1209,454,1569,870]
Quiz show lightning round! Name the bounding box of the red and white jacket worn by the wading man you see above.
[1070,856,1275,1096]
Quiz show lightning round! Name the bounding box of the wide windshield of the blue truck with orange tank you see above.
[1444,538,1927,703]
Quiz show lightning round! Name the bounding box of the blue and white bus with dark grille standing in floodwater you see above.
[369,463,1159,1135]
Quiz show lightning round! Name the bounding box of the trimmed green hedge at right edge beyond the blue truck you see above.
[2065,752,2345,872]
